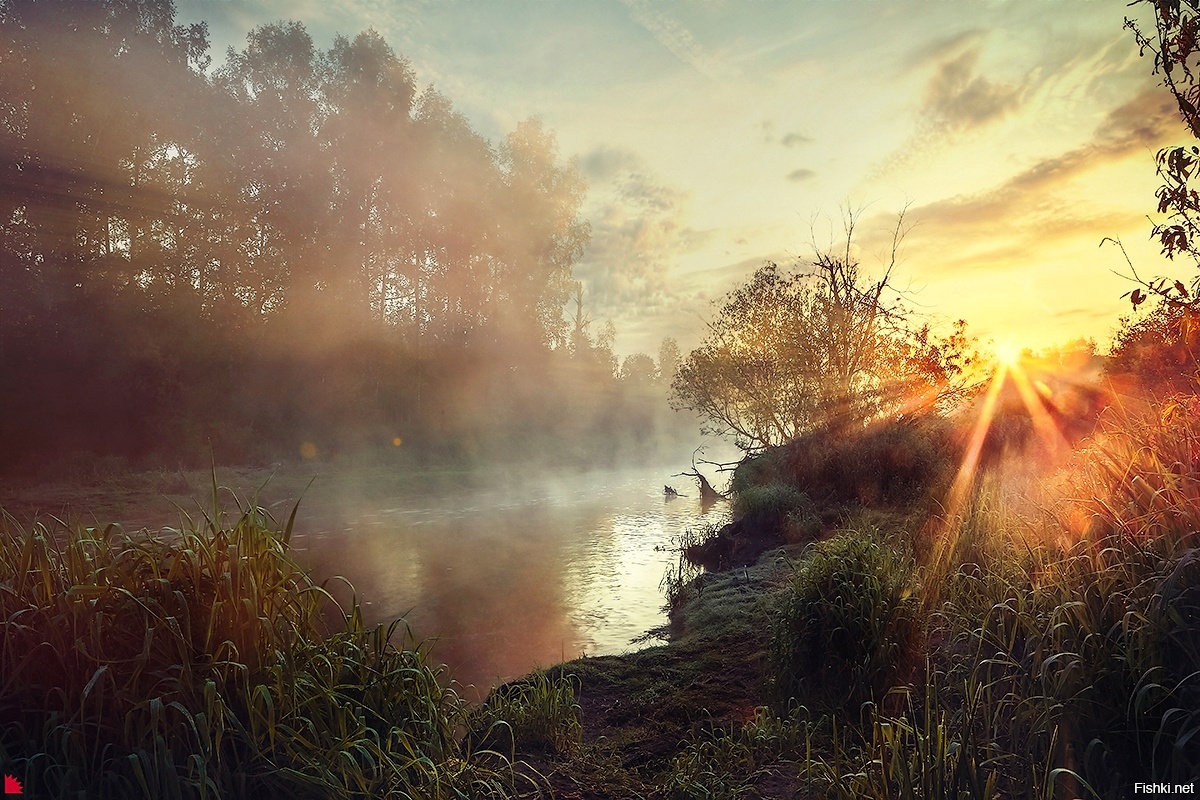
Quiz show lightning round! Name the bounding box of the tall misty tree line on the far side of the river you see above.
[0,0,696,469]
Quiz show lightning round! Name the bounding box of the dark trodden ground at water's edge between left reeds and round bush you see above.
[522,546,817,800]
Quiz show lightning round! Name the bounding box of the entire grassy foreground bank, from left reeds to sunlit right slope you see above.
[9,402,1200,800]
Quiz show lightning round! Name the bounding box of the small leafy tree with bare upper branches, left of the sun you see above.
[671,213,968,450]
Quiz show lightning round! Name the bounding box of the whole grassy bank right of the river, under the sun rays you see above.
[523,402,1200,800]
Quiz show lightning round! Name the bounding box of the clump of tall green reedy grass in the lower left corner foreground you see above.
[0,496,525,799]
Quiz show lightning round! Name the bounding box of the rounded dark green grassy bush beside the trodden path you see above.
[768,531,917,710]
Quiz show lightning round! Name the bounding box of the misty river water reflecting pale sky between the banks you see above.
[296,471,725,690]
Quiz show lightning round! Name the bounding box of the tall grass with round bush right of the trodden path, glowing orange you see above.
[753,399,1200,800]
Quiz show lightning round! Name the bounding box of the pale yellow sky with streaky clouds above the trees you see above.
[178,0,1188,354]
